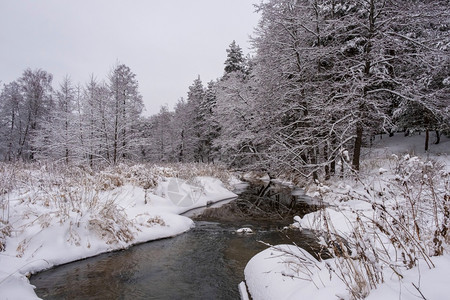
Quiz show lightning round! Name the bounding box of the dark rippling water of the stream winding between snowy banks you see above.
[31,182,315,299]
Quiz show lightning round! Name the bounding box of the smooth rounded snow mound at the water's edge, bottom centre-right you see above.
[244,245,345,300]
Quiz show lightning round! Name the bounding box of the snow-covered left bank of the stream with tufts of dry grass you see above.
[0,167,236,299]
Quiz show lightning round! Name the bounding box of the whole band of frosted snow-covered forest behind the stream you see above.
[0,0,450,179]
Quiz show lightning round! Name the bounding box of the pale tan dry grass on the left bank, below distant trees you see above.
[0,161,231,252]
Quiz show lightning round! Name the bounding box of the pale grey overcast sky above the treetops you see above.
[0,0,259,115]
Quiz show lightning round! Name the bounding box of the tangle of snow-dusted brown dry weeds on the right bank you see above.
[314,155,450,299]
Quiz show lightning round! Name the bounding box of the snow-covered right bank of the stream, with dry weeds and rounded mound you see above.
[241,134,450,300]
